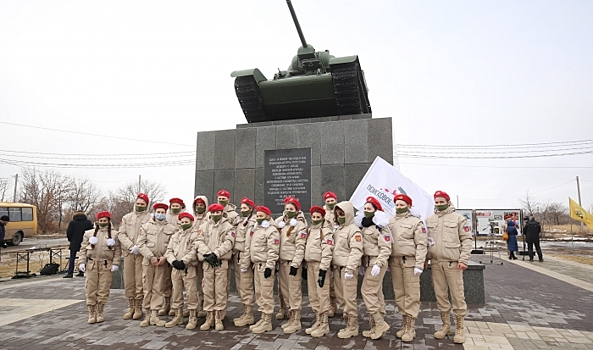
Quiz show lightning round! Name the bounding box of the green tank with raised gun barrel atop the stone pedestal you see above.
[231,0,371,123]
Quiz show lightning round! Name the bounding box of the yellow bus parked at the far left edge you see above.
[0,203,37,245]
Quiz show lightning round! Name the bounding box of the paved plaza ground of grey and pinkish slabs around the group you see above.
[0,256,593,350]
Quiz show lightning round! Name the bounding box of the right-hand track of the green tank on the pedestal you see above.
[332,62,370,115]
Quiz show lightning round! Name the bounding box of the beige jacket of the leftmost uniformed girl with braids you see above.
[78,228,121,265]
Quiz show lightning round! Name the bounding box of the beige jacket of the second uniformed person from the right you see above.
[389,211,428,269]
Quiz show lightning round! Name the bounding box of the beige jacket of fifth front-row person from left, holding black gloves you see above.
[194,216,236,261]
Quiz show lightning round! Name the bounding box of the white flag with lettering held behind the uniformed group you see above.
[350,157,434,224]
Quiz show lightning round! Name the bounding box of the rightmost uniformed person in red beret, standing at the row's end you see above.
[426,191,472,344]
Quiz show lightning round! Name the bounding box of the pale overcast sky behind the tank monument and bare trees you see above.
[0,0,593,208]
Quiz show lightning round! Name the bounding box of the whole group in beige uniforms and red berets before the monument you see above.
[79,190,472,343]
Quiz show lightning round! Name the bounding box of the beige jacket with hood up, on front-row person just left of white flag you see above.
[332,201,363,274]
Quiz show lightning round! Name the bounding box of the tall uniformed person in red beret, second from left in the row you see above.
[118,193,150,320]
